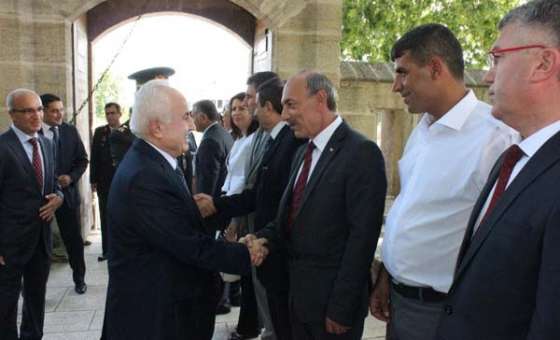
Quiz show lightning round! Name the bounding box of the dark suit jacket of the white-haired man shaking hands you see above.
[105,139,250,340]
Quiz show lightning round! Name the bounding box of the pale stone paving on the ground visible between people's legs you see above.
[19,234,385,340]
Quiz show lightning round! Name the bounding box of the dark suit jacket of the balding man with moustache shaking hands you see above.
[257,122,387,326]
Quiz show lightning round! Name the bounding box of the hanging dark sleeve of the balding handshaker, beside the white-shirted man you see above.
[327,141,387,326]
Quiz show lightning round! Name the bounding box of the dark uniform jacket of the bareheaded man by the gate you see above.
[89,125,117,191]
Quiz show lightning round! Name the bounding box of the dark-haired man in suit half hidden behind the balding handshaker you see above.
[195,79,304,340]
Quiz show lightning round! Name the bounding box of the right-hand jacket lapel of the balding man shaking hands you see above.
[296,122,348,218]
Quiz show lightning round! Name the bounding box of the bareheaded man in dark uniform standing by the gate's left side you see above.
[89,103,121,261]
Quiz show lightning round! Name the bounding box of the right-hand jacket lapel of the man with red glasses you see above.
[456,132,560,277]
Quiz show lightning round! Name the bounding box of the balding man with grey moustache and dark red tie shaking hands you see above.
[245,71,387,339]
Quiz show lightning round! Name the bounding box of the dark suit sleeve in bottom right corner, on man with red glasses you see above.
[527,205,560,340]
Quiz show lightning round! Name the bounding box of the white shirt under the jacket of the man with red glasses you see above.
[473,121,560,231]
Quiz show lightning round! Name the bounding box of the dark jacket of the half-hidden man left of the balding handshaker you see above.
[214,126,304,292]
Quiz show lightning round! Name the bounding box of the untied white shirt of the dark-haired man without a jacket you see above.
[382,91,519,292]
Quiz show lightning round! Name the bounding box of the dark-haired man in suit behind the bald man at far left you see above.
[41,93,88,294]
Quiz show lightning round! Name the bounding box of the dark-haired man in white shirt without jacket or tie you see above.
[370,24,515,340]
